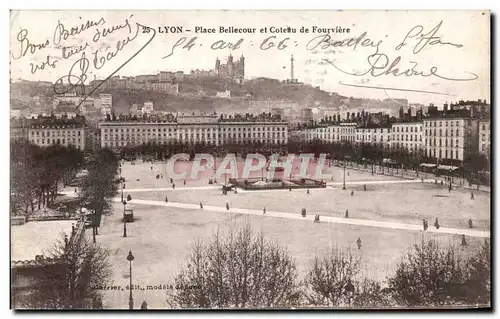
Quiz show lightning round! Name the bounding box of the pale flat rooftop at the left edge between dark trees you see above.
[11,220,76,261]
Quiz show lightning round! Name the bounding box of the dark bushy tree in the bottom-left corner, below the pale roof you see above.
[23,235,111,309]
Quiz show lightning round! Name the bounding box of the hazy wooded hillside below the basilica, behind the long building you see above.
[11,77,416,113]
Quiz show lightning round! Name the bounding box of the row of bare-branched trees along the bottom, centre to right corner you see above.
[167,226,491,308]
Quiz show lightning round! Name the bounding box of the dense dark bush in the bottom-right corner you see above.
[389,240,490,306]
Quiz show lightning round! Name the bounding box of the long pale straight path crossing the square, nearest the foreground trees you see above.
[109,197,490,238]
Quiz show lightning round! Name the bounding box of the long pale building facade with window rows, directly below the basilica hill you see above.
[99,114,288,149]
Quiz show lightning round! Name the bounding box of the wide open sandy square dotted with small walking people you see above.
[61,162,490,308]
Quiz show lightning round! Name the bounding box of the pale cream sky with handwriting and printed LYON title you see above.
[10,11,490,105]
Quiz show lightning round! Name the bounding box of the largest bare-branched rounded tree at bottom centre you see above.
[167,225,300,308]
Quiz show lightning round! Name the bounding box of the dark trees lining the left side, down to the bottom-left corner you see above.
[11,143,120,309]
